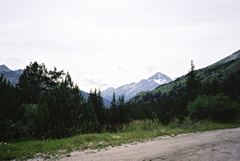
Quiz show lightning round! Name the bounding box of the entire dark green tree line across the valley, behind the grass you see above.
[0,62,240,141]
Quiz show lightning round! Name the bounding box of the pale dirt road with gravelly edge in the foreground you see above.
[61,128,240,161]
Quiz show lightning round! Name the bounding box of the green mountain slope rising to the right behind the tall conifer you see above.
[130,50,240,103]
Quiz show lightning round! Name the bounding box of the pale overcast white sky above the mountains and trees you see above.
[0,0,240,92]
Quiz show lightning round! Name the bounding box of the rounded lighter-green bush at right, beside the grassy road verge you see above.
[187,94,240,122]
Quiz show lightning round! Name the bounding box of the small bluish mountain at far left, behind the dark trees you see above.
[0,64,23,85]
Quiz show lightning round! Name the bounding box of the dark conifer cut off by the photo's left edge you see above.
[0,75,25,142]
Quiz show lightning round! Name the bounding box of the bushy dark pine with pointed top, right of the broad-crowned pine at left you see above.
[36,73,98,138]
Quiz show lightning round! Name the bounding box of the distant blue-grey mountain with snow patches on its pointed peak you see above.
[102,73,172,101]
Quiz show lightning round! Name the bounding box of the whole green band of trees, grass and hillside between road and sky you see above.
[0,50,240,159]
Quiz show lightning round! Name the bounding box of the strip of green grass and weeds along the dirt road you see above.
[0,118,240,160]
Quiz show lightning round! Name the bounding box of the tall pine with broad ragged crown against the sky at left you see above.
[17,62,64,104]
